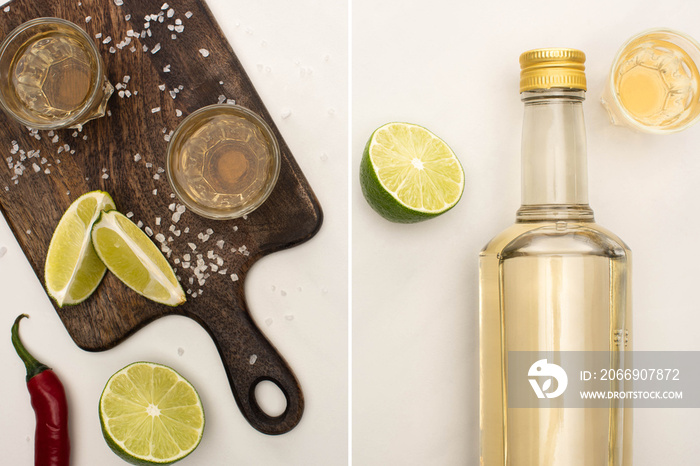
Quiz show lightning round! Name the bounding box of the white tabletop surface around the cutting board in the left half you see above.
[0,0,348,466]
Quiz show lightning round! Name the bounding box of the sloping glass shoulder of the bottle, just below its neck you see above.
[480,221,631,260]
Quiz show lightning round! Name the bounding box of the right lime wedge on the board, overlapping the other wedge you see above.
[92,210,185,306]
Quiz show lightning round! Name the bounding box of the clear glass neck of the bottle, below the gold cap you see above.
[517,89,593,222]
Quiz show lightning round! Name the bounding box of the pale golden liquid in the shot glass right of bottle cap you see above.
[613,37,700,129]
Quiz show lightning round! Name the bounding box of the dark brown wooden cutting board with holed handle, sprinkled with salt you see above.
[0,0,322,434]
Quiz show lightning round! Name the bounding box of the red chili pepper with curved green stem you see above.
[12,314,70,466]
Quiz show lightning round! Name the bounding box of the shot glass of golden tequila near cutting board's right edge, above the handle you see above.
[167,104,280,220]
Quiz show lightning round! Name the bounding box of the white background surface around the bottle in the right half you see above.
[352,0,700,466]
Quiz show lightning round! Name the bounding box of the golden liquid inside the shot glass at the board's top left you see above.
[10,31,97,123]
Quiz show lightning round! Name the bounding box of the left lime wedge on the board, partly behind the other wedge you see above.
[44,191,115,307]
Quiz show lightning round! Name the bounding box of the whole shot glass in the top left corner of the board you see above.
[0,18,114,130]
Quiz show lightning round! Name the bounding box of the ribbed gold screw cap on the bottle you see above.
[520,48,586,92]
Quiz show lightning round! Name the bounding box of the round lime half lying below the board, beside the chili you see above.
[100,362,204,464]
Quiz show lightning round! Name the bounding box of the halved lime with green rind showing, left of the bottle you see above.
[360,123,464,223]
